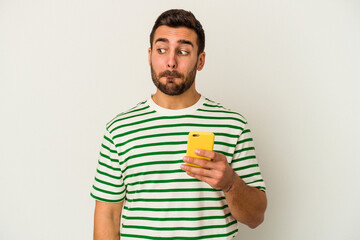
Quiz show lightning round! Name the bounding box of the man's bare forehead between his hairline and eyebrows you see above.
[153,25,197,46]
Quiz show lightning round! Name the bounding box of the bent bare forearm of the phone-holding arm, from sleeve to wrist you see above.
[225,174,267,228]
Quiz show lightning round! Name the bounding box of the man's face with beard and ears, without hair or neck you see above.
[149,26,205,96]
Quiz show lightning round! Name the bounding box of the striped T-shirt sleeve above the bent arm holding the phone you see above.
[231,123,266,191]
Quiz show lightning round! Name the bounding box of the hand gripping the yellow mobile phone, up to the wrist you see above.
[180,149,235,191]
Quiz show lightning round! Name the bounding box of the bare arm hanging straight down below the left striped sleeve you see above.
[94,201,124,240]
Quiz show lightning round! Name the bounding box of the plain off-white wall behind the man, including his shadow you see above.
[0,0,360,240]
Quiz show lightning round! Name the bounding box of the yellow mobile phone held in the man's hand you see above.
[186,132,215,167]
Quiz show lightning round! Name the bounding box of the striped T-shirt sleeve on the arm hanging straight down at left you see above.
[90,128,125,202]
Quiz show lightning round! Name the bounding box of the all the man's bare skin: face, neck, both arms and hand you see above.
[94,26,267,240]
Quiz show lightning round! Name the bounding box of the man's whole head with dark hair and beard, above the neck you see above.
[149,10,205,96]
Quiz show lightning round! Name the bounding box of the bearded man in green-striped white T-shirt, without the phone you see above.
[91,10,267,240]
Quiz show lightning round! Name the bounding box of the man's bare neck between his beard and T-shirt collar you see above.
[151,85,201,110]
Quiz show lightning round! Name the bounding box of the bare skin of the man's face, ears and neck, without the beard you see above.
[148,26,205,109]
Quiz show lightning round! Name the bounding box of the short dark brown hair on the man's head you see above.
[150,9,205,55]
